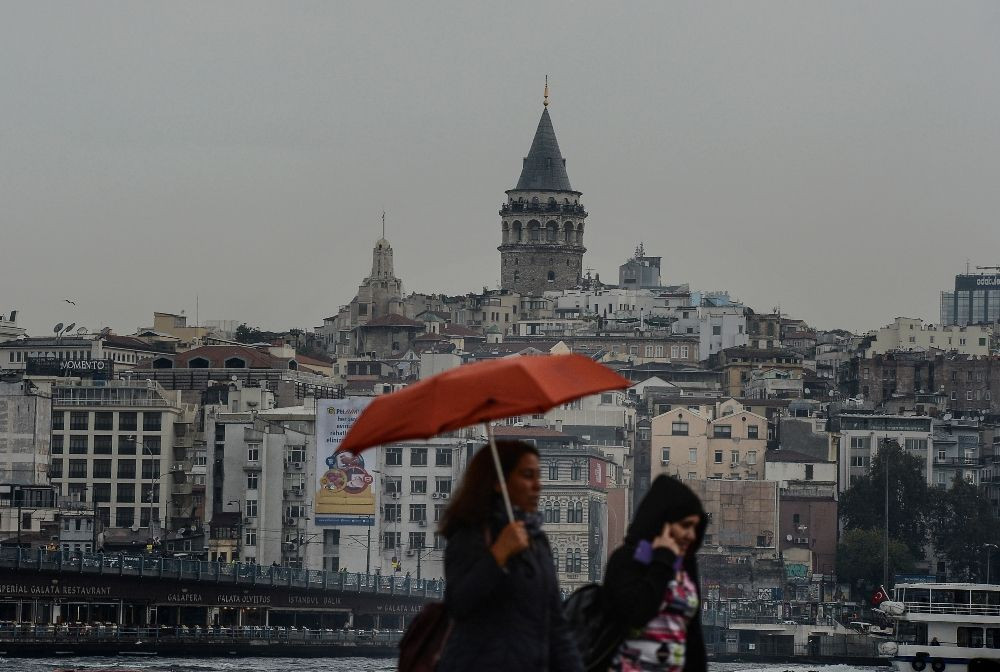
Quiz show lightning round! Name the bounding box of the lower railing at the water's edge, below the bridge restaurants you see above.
[0,623,402,646]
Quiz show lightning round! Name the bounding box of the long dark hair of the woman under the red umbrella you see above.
[438,441,538,537]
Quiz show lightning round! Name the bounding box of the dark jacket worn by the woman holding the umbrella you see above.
[437,523,582,672]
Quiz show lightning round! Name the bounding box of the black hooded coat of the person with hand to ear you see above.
[603,476,707,672]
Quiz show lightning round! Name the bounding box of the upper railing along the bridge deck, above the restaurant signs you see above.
[0,548,444,599]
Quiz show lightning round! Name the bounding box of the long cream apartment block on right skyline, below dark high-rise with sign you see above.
[865,317,993,358]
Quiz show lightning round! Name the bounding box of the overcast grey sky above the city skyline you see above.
[0,0,1000,335]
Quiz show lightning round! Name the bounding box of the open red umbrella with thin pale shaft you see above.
[337,355,630,520]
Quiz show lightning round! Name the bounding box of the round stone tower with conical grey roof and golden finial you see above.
[497,77,587,294]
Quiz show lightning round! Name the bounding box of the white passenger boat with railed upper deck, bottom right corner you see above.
[879,583,1000,672]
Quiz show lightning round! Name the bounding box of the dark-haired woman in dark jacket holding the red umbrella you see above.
[437,441,582,672]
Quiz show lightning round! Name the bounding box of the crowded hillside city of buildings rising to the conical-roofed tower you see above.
[0,96,1000,644]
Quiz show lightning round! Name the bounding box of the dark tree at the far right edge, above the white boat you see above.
[930,475,1000,581]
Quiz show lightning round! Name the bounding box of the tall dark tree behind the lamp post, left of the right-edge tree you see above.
[840,441,933,556]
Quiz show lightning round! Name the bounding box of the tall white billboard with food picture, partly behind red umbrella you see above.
[313,397,378,526]
